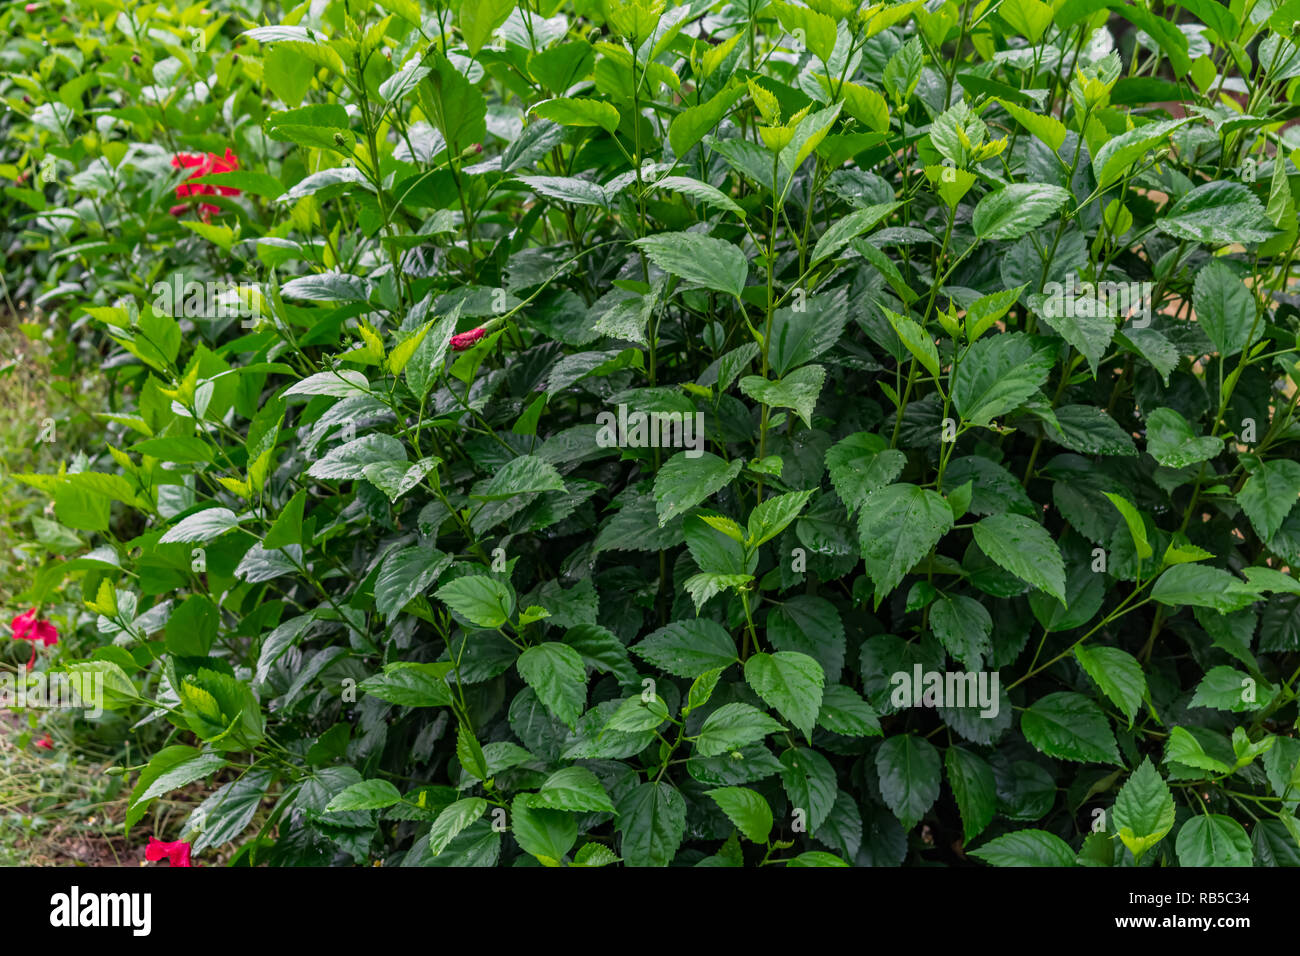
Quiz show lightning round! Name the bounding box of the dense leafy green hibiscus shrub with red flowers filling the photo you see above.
[0,0,1300,866]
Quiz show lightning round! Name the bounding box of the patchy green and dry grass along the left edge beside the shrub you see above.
[0,311,169,866]
